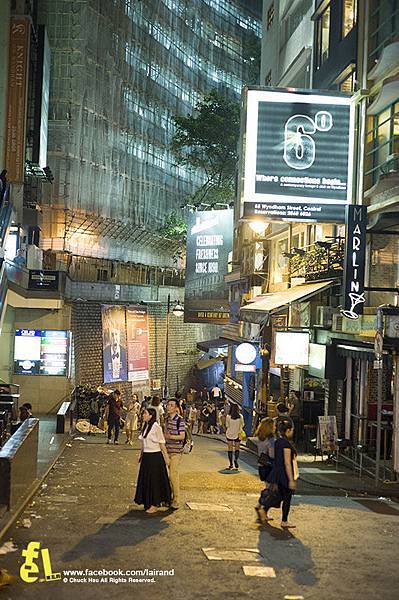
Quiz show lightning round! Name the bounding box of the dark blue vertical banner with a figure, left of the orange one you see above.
[101,304,127,383]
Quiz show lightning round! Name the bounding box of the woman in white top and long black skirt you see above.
[134,408,172,514]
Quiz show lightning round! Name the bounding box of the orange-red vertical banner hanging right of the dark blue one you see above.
[126,306,149,385]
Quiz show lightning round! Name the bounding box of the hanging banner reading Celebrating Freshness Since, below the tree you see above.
[184,210,233,323]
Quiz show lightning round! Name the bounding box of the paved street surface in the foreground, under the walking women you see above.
[2,436,399,600]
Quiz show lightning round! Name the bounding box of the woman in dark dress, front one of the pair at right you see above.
[258,417,298,529]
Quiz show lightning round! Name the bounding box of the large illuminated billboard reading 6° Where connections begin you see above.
[241,89,354,222]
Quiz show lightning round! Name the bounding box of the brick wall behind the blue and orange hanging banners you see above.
[71,302,220,394]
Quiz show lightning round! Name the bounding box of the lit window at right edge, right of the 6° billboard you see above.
[366,102,399,188]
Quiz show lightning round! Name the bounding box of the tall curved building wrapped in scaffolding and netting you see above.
[39,0,261,265]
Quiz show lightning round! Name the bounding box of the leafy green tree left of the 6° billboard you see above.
[171,91,240,206]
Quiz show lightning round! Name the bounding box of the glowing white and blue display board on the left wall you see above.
[14,329,71,377]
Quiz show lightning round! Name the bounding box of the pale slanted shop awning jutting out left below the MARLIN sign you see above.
[240,280,334,323]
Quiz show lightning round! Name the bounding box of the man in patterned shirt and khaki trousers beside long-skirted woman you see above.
[165,398,186,510]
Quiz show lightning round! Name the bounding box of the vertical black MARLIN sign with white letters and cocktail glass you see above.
[341,205,367,319]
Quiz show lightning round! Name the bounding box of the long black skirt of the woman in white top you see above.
[134,452,172,510]
